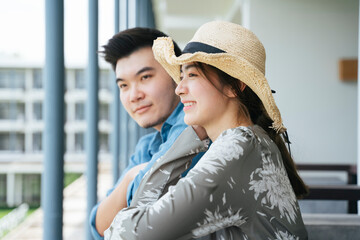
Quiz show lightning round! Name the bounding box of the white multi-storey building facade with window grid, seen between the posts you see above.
[0,64,112,207]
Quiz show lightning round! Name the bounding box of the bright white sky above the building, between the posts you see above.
[0,0,114,65]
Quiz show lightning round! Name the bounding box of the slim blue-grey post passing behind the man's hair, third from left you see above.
[111,0,120,185]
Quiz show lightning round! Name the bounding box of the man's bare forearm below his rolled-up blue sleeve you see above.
[95,163,148,236]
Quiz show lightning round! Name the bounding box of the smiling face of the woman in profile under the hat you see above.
[175,63,235,128]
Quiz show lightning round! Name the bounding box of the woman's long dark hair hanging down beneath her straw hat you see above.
[195,62,309,198]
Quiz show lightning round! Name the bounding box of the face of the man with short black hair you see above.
[115,47,179,131]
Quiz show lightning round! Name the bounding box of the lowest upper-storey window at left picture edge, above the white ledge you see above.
[0,132,25,152]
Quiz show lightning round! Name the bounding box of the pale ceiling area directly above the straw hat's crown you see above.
[153,0,242,48]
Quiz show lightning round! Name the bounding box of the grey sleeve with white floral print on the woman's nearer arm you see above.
[105,128,251,240]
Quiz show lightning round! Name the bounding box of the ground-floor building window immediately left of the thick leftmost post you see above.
[22,174,41,207]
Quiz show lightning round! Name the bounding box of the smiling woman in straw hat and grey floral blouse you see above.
[105,21,307,239]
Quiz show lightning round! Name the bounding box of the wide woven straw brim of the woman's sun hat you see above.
[153,37,286,132]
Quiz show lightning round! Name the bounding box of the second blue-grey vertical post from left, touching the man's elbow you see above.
[85,0,99,240]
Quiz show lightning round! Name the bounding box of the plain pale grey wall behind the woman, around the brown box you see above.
[249,0,359,164]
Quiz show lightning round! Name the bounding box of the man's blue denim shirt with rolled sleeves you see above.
[89,103,203,240]
